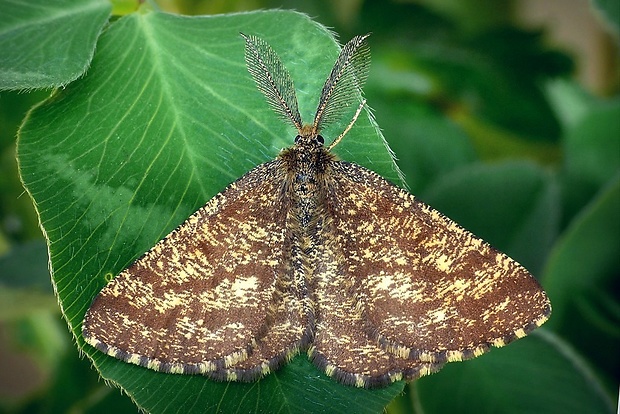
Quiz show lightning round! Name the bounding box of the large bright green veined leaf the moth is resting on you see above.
[18,7,403,412]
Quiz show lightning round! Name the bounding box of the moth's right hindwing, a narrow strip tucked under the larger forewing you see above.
[309,205,441,388]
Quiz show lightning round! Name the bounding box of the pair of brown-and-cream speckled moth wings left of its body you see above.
[83,160,308,381]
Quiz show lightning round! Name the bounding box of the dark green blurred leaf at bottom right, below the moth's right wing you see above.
[411,328,614,414]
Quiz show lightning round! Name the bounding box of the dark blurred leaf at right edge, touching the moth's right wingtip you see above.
[542,173,620,384]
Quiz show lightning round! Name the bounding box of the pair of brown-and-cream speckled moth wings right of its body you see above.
[313,161,551,385]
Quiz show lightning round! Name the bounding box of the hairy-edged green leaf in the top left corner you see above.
[0,0,112,90]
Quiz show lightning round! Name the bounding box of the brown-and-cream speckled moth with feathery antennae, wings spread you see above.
[82,35,551,388]
